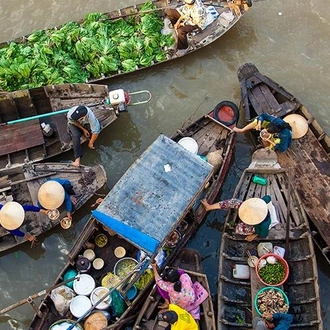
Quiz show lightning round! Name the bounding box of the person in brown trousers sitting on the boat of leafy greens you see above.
[166,0,207,56]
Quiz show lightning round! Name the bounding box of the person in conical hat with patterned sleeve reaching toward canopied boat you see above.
[201,195,271,242]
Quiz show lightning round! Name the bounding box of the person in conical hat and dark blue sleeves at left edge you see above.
[0,202,47,242]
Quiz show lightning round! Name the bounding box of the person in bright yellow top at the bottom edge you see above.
[157,304,198,330]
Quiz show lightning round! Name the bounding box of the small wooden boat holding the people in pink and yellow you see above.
[133,248,216,330]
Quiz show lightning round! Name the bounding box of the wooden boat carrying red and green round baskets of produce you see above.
[218,150,323,330]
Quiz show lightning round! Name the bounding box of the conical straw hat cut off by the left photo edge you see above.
[0,202,25,230]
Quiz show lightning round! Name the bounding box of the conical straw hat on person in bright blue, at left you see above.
[38,180,65,210]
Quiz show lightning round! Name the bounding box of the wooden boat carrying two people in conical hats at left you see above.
[0,163,106,252]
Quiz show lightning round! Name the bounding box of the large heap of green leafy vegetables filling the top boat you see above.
[0,2,175,91]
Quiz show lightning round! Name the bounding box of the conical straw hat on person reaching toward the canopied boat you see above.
[238,198,268,225]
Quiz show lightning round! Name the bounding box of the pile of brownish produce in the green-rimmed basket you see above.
[257,289,289,314]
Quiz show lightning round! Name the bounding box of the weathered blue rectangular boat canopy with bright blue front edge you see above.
[93,135,212,255]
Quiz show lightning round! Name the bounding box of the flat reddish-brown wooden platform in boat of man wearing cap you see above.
[0,119,45,156]
